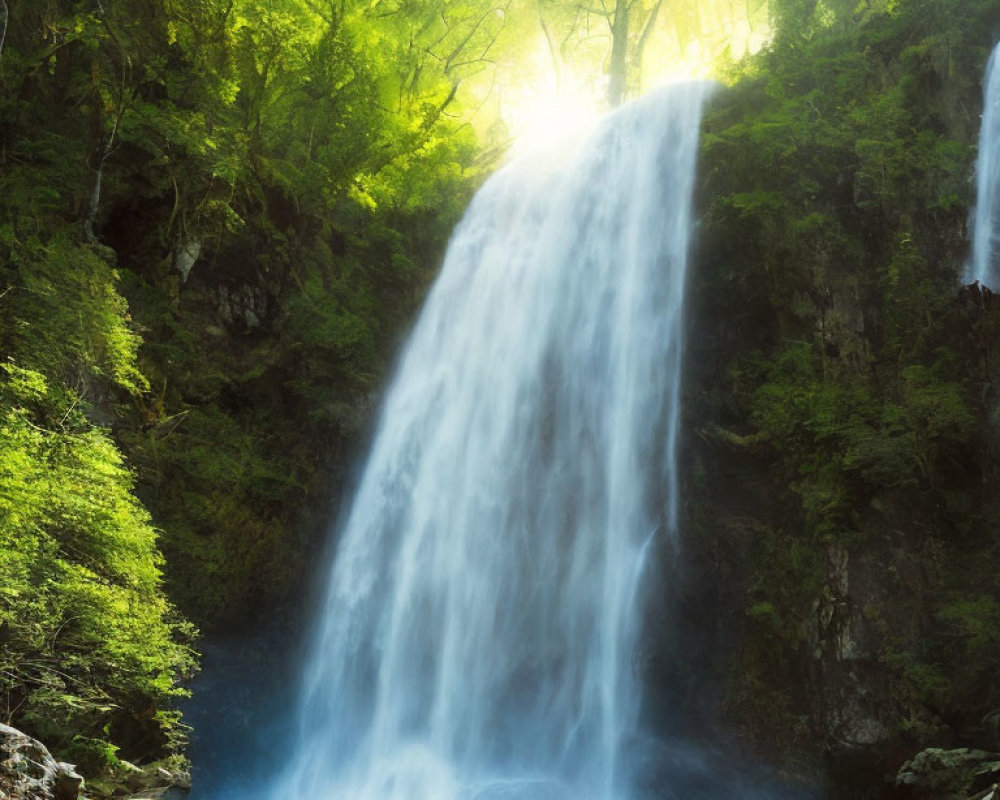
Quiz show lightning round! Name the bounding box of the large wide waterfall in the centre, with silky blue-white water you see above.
[270,85,705,800]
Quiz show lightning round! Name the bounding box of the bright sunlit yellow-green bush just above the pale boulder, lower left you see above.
[0,364,194,772]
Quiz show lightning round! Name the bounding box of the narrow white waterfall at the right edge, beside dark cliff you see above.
[968,44,1000,291]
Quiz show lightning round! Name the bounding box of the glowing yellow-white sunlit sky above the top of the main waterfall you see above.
[474,0,770,153]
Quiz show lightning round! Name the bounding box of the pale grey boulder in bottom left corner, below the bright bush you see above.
[0,725,83,800]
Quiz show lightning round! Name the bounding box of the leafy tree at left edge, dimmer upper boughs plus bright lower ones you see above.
[0,231,194,776]
